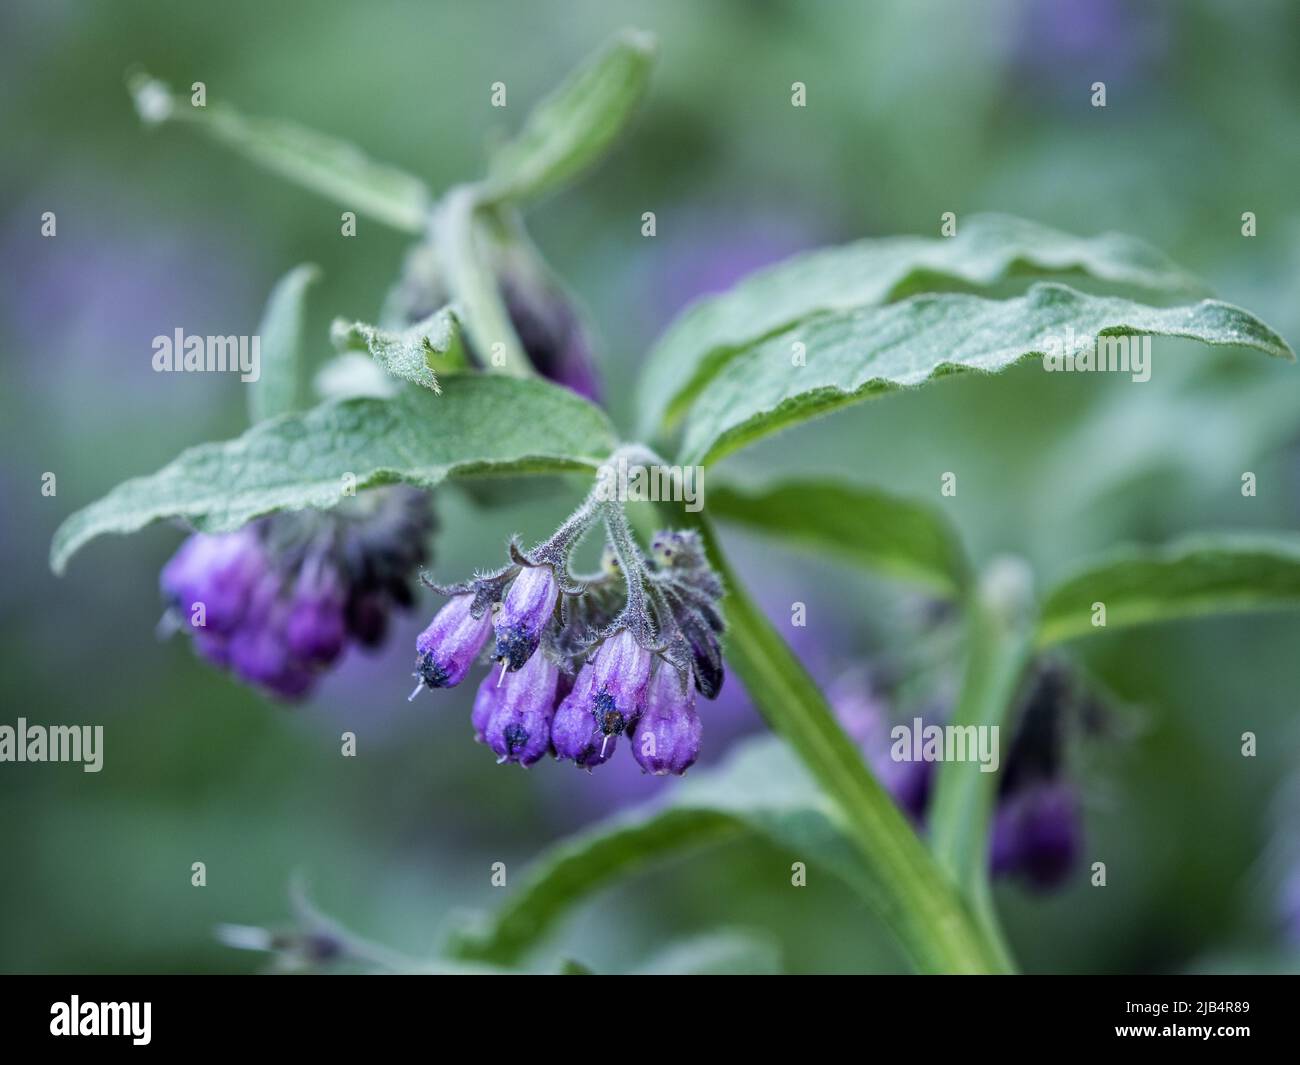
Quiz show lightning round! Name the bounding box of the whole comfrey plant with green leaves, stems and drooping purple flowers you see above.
[51,31,1300,971]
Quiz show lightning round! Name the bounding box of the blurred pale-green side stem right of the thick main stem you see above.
[930,560,1032,953]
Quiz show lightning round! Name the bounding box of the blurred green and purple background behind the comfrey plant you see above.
[0,0,1300,971]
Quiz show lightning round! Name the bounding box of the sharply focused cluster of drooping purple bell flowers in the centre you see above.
[412,532,723,775]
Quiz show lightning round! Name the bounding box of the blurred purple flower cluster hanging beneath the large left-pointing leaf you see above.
[161,486,433,700]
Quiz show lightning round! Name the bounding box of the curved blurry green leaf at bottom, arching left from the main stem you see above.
[452,736,863,965]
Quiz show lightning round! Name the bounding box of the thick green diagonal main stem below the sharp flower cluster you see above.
[673,510,1010,973]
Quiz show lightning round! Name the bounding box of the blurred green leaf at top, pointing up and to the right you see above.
[482,30,655,202]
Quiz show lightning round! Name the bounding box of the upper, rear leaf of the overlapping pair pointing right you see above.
[640,215,1208,437]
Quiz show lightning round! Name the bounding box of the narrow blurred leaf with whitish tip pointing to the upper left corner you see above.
[127,72,430,234]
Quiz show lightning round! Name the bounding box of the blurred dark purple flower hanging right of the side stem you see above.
[989,780,1083,889]
